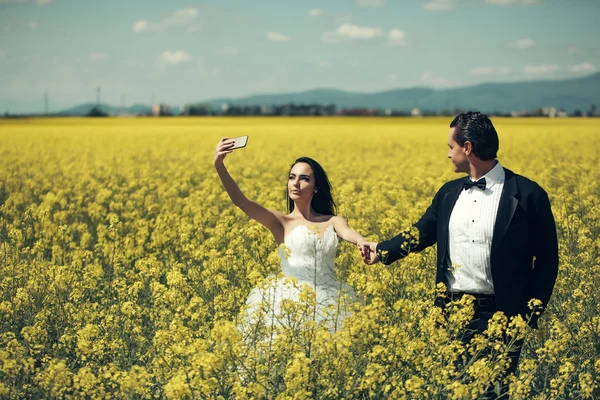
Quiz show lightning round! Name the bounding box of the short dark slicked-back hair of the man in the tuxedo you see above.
[450,111,499,161]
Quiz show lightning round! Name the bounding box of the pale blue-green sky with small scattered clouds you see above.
[0,0,600,111]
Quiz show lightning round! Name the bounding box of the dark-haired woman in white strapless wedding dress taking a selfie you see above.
[214,138,367,332]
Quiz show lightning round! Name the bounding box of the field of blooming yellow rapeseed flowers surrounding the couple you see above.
[0,118,600,399]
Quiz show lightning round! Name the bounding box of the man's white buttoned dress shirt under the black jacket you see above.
[446,162,505,294]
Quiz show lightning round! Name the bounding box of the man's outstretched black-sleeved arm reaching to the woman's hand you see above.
[376,190,442,265]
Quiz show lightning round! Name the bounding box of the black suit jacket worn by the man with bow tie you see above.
[377,168,558,326]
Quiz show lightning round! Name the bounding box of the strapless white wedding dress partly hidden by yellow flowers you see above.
[240,225,359,333]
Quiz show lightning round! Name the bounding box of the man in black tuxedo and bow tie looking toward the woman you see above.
[362,112,558,373]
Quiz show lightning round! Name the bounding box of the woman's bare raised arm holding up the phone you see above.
[214,137,284,244]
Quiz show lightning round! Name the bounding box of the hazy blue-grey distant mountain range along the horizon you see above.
[5,73,600,115]
